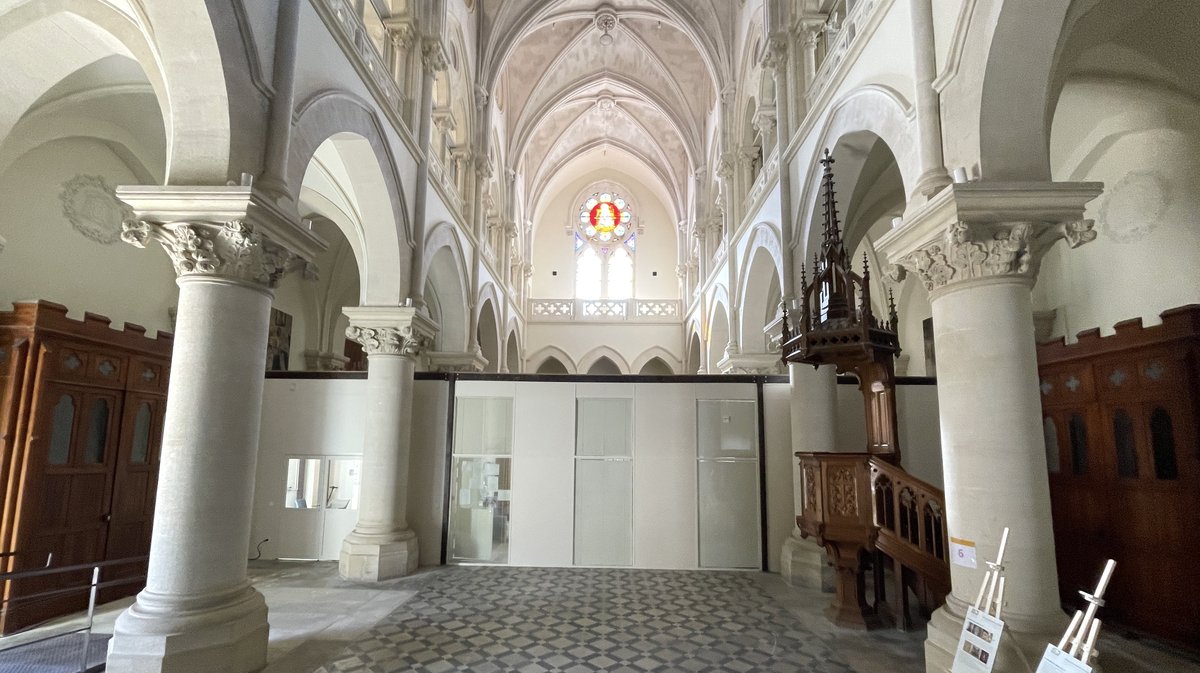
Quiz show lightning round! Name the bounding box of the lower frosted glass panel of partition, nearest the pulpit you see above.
[698,461,762,567]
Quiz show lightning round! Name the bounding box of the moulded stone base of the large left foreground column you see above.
[107,584,269,673]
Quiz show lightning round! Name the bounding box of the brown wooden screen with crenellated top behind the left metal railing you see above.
[0,301,173,633]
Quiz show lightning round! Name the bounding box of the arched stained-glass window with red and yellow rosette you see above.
[575,192,637,300]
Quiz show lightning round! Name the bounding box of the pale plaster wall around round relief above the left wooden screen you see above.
[0,138,179,335]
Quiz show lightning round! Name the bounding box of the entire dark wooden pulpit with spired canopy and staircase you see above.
[782,150,950,629]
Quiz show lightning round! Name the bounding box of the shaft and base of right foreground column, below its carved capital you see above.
[929,276,1064,669]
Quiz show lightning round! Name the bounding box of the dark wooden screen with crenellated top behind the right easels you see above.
[1038,305,1200,648]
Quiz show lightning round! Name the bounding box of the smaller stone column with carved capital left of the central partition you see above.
[337,306,434,582]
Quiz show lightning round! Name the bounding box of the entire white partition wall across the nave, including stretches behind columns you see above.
[247,378,941,569]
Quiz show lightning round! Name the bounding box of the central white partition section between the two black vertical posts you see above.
[450,381,758,569]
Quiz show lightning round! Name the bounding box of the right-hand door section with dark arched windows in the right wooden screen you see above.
[1096,349,1200,643]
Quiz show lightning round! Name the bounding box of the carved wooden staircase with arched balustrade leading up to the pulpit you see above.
[870,458,950,630]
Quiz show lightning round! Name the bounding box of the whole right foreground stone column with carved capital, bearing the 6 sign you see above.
[878,182,1102,673]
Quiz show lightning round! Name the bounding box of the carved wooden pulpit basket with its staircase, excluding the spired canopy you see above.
[796,452,950,629]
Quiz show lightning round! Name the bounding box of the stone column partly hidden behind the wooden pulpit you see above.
[780,362,835,591]
